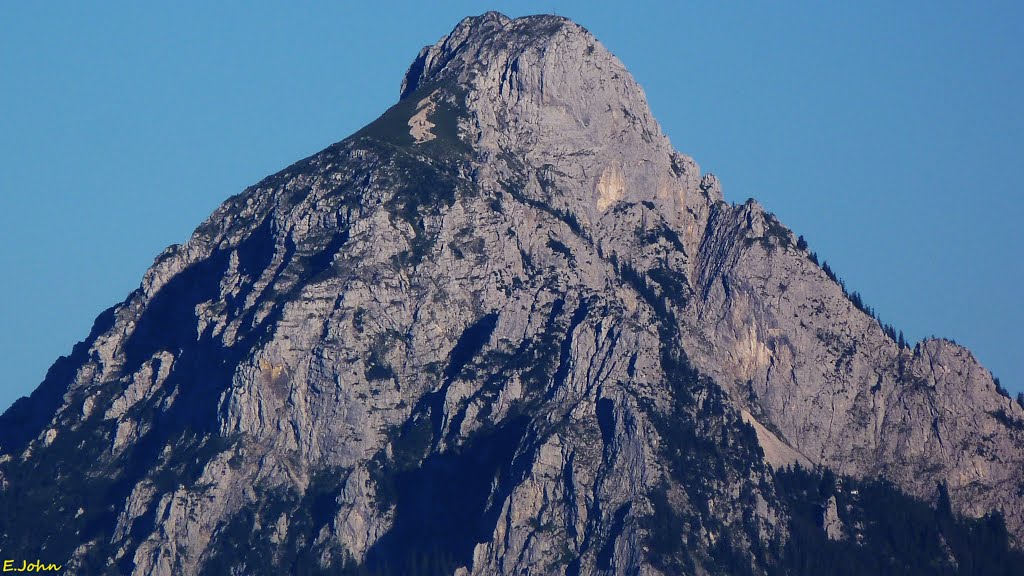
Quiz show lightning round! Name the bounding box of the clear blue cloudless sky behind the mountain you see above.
[0,1,1024,407]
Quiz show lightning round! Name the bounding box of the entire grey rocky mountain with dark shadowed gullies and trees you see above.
[0,12,1024,575]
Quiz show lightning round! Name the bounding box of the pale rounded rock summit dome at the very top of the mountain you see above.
[401,12,704,237]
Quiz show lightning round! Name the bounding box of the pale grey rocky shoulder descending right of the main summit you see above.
[687,195,1024,534]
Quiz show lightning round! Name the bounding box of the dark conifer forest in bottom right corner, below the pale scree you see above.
[773,467,1024,576]
